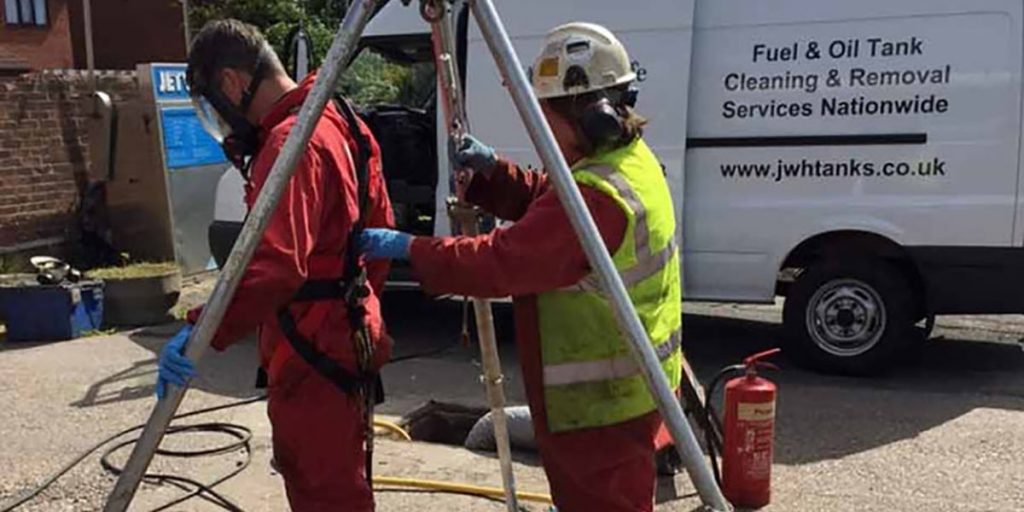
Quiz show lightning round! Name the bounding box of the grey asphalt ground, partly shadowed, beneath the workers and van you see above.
[0,292,1024,512]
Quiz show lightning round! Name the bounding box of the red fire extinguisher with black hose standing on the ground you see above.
[722,348,780,508]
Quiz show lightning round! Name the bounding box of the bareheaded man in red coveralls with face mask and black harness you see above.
[157,20,393,512]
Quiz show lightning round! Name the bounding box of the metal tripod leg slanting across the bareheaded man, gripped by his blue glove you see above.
[103,0,379,512]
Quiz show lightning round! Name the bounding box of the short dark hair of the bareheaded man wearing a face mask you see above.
[185,19,285,94]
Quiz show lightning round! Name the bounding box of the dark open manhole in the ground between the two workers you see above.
[401,400,487,446]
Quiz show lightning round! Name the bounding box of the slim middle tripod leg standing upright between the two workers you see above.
[421,0,519,512]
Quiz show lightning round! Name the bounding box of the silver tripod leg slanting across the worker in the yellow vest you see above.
[470,0,731,511]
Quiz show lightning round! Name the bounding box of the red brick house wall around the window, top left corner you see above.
[0,0,73,70]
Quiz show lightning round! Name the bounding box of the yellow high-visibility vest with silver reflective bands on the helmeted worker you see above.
[538,138,683,432]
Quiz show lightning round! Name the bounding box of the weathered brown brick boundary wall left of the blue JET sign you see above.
[0,71,138,253]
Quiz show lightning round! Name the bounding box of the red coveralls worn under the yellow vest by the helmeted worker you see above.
[410,160,662,512]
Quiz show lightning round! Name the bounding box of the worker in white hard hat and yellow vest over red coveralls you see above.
[361,23,682,512]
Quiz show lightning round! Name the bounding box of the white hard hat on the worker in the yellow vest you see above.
[530,22,637,99]
